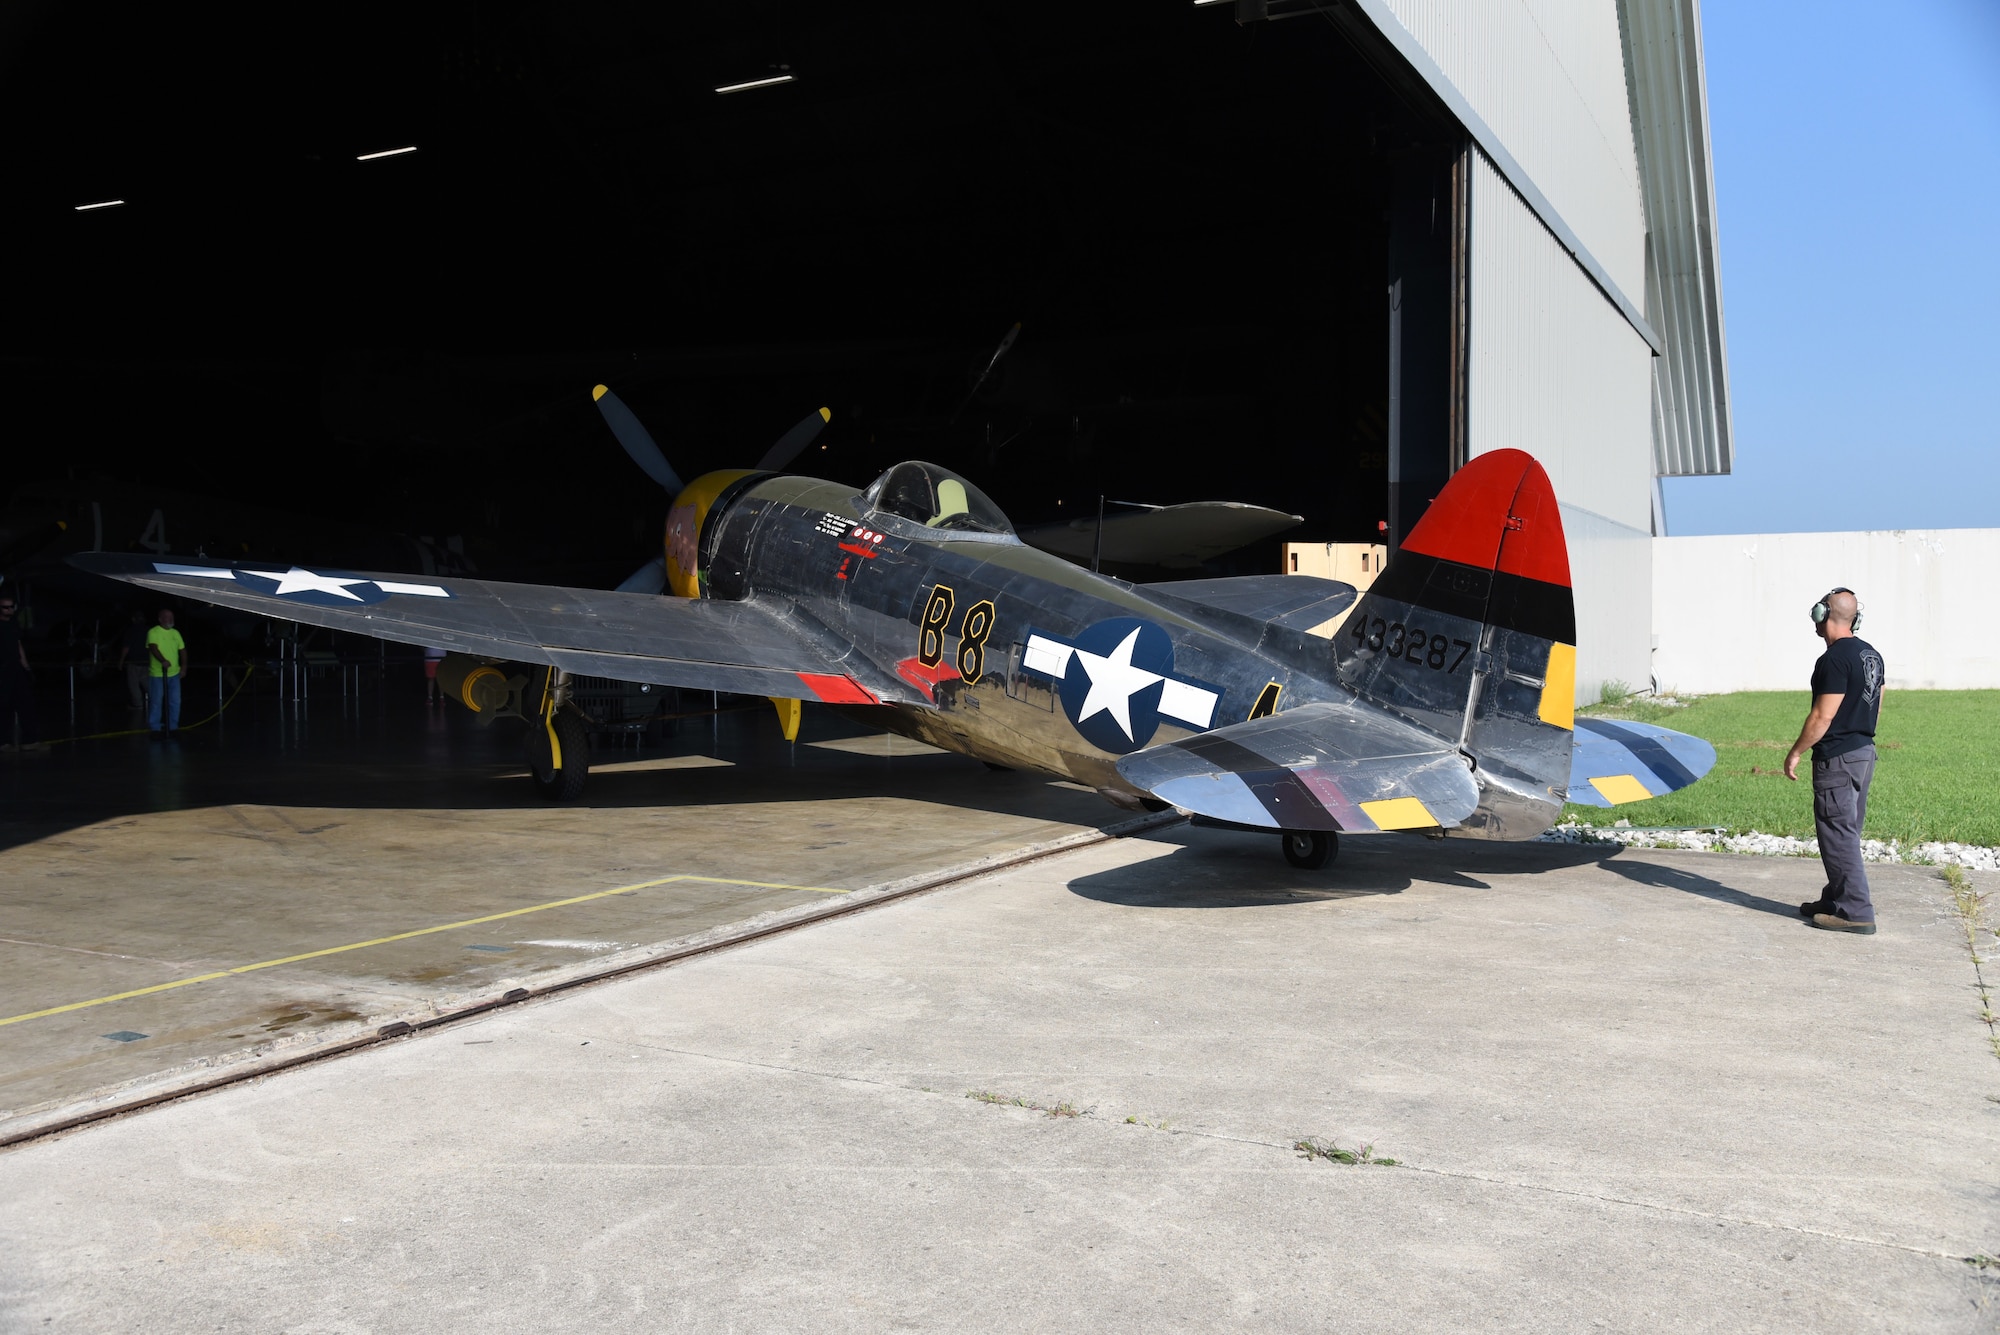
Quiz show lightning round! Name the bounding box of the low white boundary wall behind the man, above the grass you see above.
[1640,528,2000,695]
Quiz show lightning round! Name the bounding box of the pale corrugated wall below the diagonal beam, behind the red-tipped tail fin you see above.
[1466,150,1652,699]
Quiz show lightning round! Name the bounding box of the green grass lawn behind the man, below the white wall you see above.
[1562,689,2000,845]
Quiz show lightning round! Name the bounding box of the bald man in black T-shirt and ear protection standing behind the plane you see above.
[1784,590,1882,935]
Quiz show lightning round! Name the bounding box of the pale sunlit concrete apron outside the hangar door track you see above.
[0,827,2000,1331]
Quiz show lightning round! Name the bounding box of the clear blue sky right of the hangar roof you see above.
[1664,0,2000,534]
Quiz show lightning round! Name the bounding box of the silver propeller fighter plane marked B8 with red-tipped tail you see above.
[70,386,1714,867]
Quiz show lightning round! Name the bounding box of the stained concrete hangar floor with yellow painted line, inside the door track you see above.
[0,719,1160,1145]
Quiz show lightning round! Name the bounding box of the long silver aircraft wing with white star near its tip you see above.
[70,552,930,703]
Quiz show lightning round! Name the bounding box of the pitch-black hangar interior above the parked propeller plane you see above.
[0,0,1462,584]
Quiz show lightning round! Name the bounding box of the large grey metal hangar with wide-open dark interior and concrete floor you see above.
[0,0,1730,1143]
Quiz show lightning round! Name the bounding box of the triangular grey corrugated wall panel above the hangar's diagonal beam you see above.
[1386,0,1646,302]
